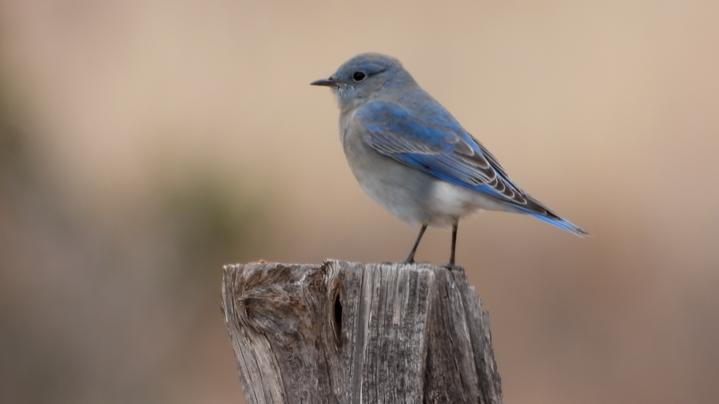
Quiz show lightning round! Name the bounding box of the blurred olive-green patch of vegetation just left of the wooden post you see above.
[158,167,266,304]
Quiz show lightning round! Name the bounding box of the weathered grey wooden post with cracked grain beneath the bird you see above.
[222,260,502,404]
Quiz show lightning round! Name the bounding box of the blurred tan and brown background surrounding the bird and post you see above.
[0,0,719,404]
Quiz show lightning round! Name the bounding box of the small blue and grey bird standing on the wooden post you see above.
[311,53,589,268]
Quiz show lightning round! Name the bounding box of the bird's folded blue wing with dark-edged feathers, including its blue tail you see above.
[356,98,588,235]
